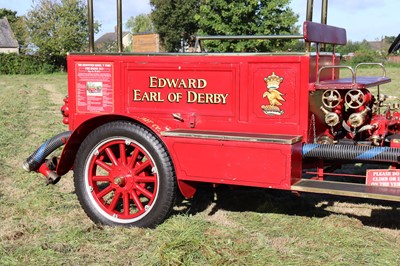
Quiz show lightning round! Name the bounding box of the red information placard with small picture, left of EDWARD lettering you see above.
[76,62,114,113]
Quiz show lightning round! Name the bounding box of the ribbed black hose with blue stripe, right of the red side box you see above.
[303,144,400,163]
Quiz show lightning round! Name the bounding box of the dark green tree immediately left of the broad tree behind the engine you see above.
[150,0,199,52]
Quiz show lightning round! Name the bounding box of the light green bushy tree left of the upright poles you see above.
[27,0,99,66]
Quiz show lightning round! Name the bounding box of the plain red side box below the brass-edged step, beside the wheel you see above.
[164,137,301,189]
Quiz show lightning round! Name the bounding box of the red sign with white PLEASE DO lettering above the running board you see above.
[366,169,400,187]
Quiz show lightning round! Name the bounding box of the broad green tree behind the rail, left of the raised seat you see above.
[195,0,298,52]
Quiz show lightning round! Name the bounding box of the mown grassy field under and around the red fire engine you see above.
[0,68,400,265]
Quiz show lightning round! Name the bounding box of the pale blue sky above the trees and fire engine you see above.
[0,0,400,41]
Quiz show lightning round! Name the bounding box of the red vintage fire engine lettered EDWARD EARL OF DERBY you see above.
[23,0,400,227]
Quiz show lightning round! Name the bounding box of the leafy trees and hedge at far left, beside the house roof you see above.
[0,0,100,74]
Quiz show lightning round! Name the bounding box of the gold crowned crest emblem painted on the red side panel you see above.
[261,72,285,115]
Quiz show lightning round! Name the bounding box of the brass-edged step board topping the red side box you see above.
[161,130,302,144]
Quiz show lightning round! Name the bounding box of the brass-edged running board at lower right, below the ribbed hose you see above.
[291,179,400,202]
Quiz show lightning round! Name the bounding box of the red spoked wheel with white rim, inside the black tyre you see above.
[85,137,159,223]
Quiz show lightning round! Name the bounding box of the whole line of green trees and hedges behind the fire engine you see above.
[0,0,398,73]
